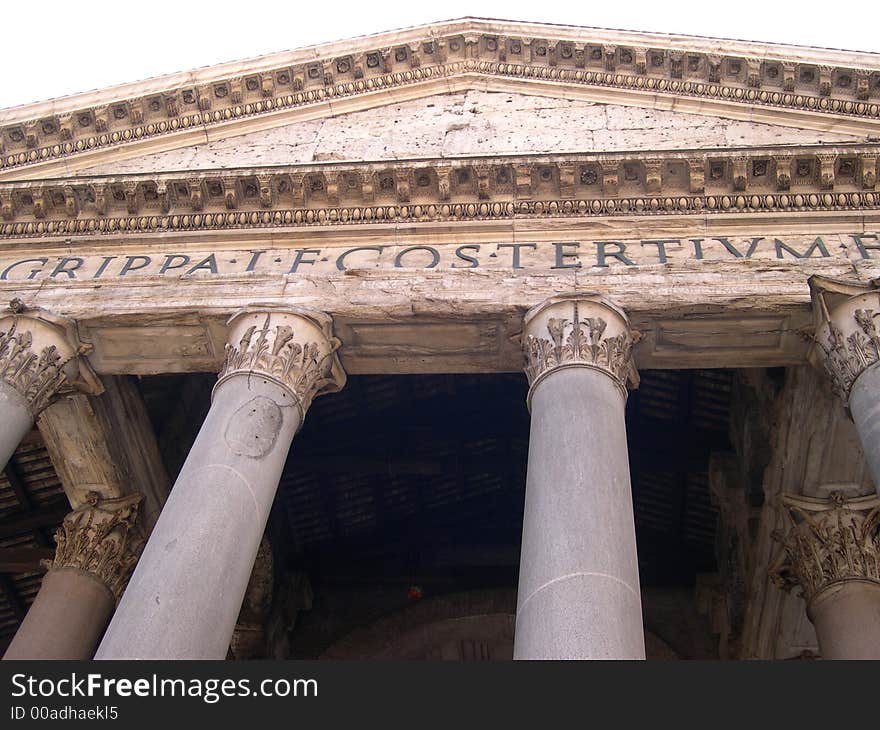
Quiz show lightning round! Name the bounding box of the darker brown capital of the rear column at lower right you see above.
[770,492,880,605]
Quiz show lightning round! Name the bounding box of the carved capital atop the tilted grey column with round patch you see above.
[215,306,345,417]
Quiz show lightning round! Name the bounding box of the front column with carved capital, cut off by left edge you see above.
[0,299,101,470]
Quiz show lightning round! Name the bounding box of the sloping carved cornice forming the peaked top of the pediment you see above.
[0,19,880,179]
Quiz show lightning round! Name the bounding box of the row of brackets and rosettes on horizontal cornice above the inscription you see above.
[0,145,880,221]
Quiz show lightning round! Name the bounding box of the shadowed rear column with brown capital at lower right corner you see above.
[771,491,880,659]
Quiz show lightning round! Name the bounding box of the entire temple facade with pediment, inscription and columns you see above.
[0,19,880,660]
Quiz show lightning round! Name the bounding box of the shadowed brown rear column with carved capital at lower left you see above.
[3,492,141,659]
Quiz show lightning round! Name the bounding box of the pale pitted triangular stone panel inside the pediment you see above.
[72,91,862,176]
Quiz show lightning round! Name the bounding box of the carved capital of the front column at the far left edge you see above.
[0,299,101,416]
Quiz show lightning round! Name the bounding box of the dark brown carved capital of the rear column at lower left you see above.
[43,492,143,601]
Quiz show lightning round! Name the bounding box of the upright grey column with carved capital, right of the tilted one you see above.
[514,296,645,659]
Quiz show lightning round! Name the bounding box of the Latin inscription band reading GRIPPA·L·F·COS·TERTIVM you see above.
[0,233,880,282]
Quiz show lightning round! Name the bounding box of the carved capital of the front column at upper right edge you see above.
[810,276,880,404]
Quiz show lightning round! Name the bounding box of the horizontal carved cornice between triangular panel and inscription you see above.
[0,144,880,240]
